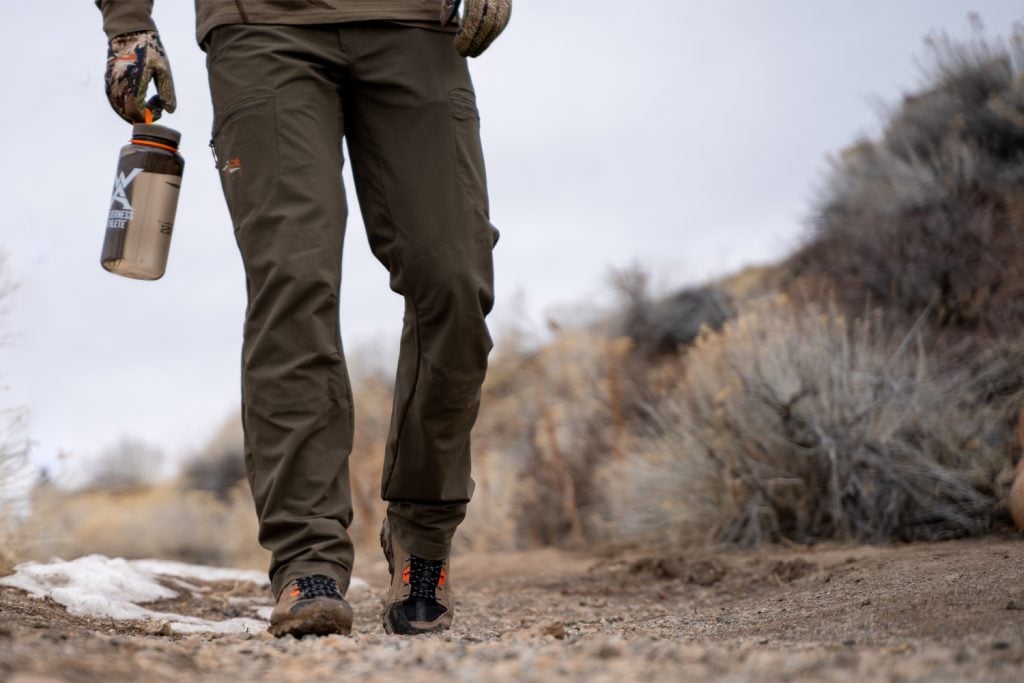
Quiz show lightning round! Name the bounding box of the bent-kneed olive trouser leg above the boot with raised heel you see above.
[340,25,498,559]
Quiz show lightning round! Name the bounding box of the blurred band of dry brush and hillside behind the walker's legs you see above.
[0,21,1024,569]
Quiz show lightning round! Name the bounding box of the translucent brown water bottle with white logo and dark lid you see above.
[99,123,185,280]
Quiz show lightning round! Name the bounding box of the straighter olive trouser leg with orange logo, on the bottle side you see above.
[208,26,352,595]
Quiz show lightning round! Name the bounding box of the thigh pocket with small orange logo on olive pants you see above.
[211,88,279,231]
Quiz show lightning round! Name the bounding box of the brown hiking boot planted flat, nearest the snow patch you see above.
[268,573,352,638]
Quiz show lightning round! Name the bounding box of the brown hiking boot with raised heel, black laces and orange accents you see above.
[381,519,455,636]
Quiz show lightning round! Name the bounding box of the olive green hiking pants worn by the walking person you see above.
[205,23,498,595]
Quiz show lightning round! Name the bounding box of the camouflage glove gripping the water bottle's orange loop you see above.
[106,31,177,123]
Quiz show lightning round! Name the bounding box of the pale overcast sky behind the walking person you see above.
[0,0,1024,481]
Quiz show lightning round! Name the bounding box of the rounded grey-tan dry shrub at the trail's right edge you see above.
[606,299,1022,545]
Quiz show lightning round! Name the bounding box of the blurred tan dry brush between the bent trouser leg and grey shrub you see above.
[465,331,640,549]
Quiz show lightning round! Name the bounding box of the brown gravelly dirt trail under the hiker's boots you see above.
[0,535,1024,683]
